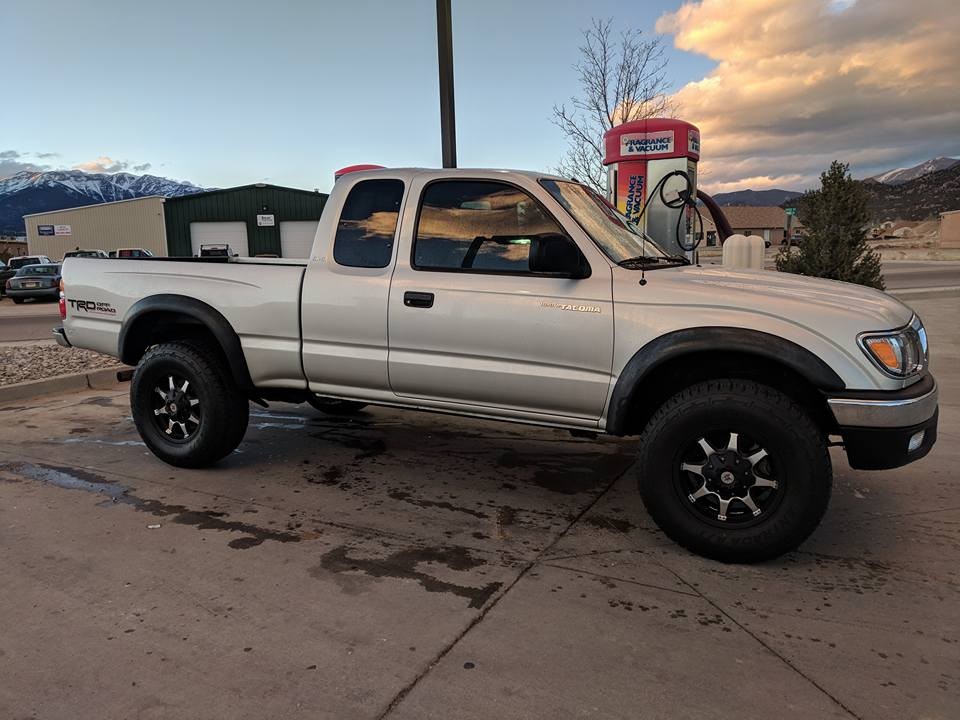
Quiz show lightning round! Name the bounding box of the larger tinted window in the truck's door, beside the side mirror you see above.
[413,180,564,273]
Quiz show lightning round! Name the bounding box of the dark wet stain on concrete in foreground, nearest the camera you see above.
[310,546,503,608]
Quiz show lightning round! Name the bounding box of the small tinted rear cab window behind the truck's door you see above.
[333,180,403,267]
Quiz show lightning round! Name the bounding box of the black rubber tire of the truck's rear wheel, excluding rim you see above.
[130,342,250,468]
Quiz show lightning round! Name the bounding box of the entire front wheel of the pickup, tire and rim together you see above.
[637,379,832,562]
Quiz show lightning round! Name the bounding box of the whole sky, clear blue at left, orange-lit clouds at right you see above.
[0,0,960,192]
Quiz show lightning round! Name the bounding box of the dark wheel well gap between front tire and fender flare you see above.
[623,350,837,435]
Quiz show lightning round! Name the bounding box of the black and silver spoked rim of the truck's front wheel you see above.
[673,429,783,529]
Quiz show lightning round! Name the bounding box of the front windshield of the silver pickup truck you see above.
[540,180,668,263]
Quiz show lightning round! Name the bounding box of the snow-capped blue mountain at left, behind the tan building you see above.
[0,170,205,233]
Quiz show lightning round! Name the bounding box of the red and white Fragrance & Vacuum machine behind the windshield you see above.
[603,118,700,254]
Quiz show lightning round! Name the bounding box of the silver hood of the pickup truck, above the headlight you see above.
[624,266,913,330]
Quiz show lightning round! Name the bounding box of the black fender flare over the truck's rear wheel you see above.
[117,294,253,391]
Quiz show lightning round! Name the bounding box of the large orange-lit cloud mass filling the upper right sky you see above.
[656,0,960,192]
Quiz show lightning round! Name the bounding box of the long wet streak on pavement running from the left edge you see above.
[0,463,302,550]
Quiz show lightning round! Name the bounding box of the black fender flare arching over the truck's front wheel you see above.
[606,327,846,435]
